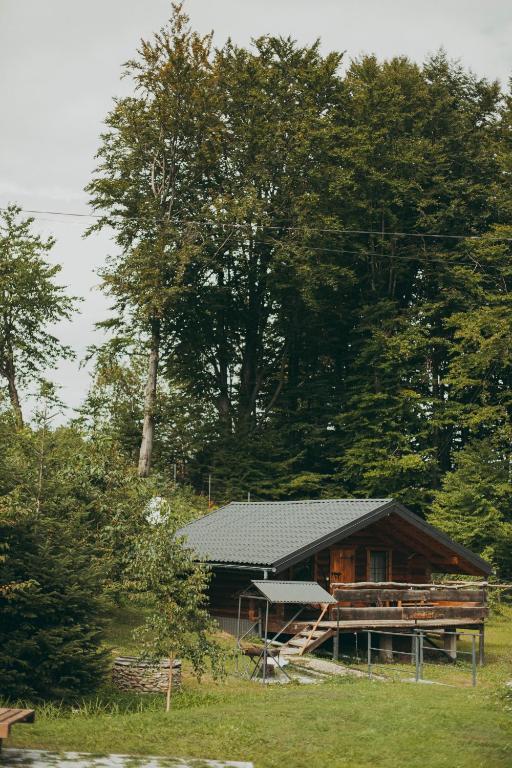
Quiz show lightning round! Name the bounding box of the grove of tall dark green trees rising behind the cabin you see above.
[85,7,512,559]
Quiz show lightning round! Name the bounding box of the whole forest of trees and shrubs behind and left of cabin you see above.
[0,0,512,696]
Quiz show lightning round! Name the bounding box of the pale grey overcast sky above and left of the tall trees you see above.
[0,0,512,420]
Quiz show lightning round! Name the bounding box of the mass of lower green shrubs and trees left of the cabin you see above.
[0,385,206,703]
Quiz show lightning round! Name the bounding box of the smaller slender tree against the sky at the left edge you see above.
[0,205,75,426]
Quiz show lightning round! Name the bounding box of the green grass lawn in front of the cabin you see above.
[8,609,512,768]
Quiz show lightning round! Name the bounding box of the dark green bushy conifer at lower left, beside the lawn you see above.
[0,499,107,701]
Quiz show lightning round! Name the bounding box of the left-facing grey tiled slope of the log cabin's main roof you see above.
[178,499,391,567]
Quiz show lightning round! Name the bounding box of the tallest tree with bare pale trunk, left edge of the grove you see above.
[88,4,217,477]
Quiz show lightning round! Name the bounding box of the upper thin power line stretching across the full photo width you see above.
[0,207,512,242]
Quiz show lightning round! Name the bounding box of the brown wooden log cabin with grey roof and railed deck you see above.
[179,499,491,653]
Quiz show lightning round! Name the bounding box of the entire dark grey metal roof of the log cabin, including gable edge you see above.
[178,499,492,574]
